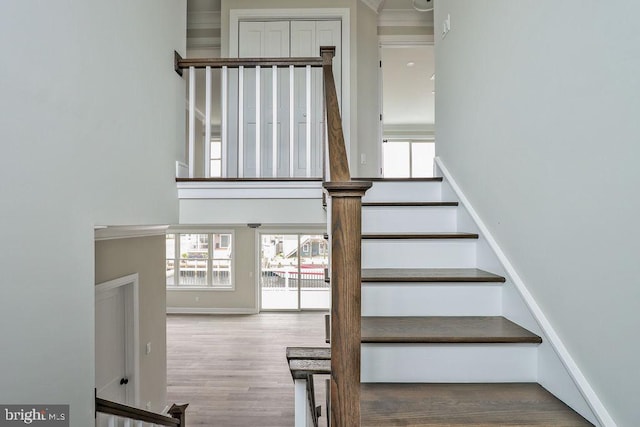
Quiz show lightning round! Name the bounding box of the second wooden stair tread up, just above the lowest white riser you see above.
[361,316,542,344]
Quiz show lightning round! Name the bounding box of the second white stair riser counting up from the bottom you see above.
[362,283,502,316]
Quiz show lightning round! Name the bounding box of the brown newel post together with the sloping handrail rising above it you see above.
[320,47,371,427]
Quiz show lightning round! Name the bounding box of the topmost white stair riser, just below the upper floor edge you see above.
[362,182,442,202]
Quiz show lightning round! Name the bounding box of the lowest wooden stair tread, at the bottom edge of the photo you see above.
[360,383,592,427]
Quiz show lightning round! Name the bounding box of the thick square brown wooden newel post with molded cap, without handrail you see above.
[324,181,371,427]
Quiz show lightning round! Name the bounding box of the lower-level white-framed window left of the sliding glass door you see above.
[166,233,233,288]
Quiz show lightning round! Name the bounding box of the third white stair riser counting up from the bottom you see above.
[362,239,476,268]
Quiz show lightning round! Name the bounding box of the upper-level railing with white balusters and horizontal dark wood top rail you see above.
[175,52,323,178]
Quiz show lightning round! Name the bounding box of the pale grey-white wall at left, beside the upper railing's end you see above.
[0,0,186,427]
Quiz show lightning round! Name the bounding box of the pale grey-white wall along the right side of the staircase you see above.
[435,0,640,426]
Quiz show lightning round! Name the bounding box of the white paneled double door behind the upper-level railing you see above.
[238,20,342,177]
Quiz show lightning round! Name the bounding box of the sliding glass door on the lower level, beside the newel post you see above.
[260,234,331,310]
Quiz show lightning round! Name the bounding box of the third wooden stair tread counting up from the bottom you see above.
[362,268,505,283]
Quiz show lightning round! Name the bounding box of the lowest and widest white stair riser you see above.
[361,344,538,383]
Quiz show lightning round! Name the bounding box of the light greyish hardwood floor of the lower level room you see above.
[167,312,326,427]
